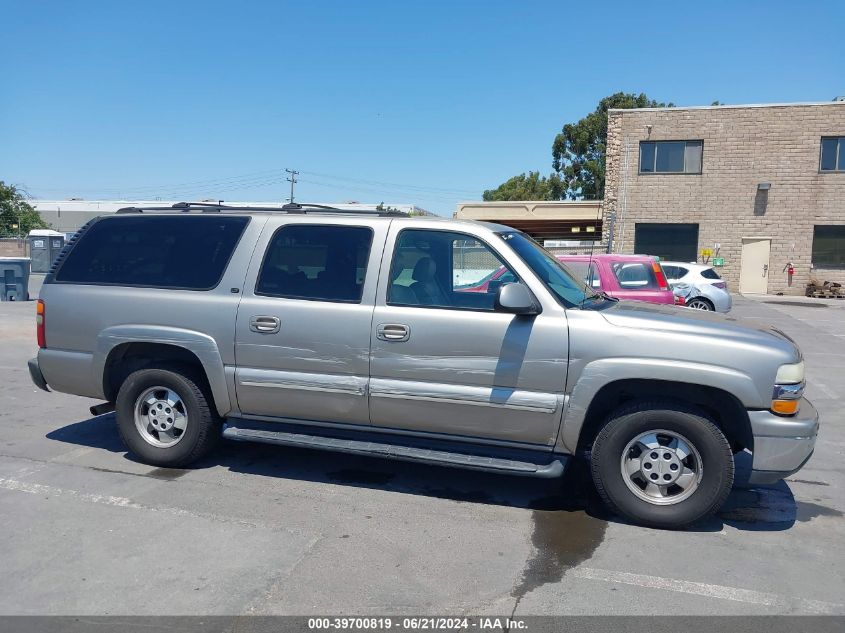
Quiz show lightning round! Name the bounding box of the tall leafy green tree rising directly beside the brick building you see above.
[552,92,673,200]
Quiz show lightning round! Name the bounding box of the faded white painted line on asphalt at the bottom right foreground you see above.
[567,567,845,614]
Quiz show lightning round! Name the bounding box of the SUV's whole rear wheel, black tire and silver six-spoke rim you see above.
[115,368,220,468]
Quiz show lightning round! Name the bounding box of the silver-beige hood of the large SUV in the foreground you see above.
[601,301,801,362]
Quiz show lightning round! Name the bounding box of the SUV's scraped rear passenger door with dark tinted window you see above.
[235,217,389,424]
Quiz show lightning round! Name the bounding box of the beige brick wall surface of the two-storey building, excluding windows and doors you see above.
[605,102,845,294]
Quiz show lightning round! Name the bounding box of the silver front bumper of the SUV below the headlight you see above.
[748,398,819,484]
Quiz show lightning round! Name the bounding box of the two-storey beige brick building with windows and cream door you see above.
[604,100,845,294]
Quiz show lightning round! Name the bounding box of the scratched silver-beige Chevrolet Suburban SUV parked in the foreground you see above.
[29,203,818,527]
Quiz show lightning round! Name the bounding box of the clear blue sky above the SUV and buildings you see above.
[0,0,845,215]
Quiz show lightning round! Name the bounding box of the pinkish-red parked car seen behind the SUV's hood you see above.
[558,253,676,304]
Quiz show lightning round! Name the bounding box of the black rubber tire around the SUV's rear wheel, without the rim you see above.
[115,367,221,468]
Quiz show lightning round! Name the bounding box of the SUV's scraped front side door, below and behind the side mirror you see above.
[370,221,568,449]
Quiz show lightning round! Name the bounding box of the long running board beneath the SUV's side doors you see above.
[223,418,569,478]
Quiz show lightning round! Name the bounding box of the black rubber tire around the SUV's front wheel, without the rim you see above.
[590,401,734,529]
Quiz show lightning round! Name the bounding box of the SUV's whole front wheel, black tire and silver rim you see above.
[591,402,734,528]
